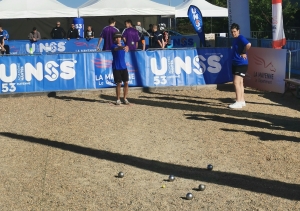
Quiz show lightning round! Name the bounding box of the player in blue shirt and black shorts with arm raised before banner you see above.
[111,32,129,105]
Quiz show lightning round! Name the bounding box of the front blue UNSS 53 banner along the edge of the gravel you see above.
[0,48,232,93]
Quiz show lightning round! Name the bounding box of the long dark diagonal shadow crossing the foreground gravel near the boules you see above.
[0,132,300,200]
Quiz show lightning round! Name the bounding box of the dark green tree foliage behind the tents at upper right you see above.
[177,0,300,34]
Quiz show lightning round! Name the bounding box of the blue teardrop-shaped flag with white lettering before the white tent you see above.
[188,5,206,47]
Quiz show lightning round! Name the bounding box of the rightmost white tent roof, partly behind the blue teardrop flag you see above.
[175,0,228,18]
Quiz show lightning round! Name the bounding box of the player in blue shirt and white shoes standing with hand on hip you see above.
[229,23,251,109]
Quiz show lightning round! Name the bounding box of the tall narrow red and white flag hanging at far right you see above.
[272,0,286,49]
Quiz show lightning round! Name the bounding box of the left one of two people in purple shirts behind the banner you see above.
[97,18,119,51]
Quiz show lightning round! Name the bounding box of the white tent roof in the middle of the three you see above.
[79,0,175,17]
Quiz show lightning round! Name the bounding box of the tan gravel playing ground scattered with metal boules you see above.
[0,85,300,211]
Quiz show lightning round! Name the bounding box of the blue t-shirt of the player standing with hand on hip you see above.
[231,35,249,66]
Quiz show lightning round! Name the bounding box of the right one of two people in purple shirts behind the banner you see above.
[122,20,140,51]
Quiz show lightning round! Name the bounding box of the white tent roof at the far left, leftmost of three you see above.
[0,0,78,19]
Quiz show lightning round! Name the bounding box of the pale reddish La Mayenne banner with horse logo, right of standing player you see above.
[244,47,287,93]
